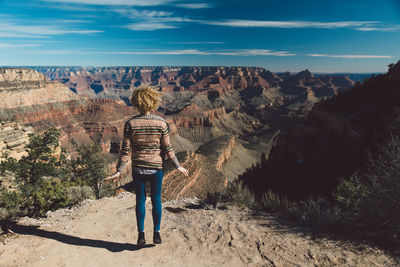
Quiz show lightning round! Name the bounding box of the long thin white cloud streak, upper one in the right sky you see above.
[201,19,398,31]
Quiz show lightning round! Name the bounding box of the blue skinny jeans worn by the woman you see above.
[132,170,163,232]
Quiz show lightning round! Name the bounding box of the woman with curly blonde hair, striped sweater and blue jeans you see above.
[112,86,189,246]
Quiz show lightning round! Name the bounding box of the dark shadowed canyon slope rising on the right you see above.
[238,62,400,199]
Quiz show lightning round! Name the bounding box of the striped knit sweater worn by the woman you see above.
[117,114,179,173]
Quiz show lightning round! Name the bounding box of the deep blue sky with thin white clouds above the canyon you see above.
[0,0,400,73]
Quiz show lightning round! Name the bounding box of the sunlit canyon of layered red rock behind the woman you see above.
[0,66,354,200]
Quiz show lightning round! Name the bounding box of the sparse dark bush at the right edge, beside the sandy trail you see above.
[334,136,400,244]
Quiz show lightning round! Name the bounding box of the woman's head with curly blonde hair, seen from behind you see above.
[131,85,161,113]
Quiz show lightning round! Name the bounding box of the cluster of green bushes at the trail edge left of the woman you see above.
[0,128,112,218]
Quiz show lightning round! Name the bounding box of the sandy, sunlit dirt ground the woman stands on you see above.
[0,192,399,267]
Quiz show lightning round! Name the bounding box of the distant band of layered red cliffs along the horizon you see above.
[35,67,354,110]
